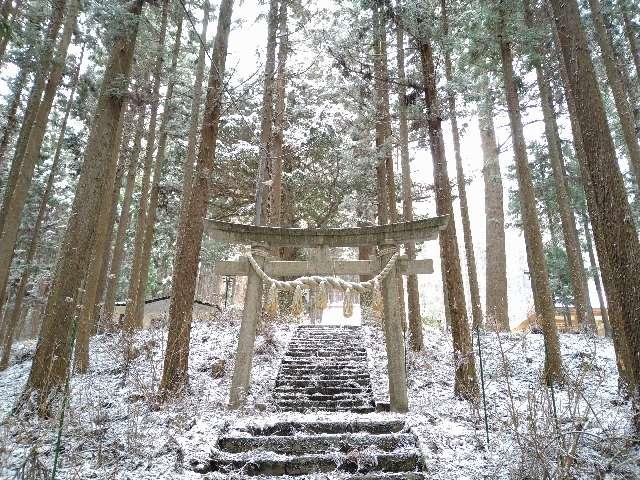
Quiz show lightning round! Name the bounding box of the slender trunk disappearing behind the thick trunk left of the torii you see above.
[180,0,211,220]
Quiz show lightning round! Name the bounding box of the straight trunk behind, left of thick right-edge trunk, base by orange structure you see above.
[523,0,596,333]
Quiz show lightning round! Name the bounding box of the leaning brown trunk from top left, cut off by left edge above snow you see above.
[0,0,78,322]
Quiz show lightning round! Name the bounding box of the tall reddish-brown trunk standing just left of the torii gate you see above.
[160,0,233,394]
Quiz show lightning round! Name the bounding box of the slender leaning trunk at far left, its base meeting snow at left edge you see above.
[0,44,85,370]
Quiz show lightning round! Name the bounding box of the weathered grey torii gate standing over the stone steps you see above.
[208,215,449,412]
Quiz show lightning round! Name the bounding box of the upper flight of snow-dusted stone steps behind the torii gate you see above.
[274,325,375,413]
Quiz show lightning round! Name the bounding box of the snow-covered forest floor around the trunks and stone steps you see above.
[0,311,640,480]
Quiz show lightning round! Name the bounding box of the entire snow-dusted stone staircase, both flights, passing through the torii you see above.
[191,325,426,480]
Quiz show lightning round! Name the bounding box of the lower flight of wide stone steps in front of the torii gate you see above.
[192,414,426,480]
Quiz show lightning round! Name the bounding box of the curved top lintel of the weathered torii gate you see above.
[207,215,449,247]
